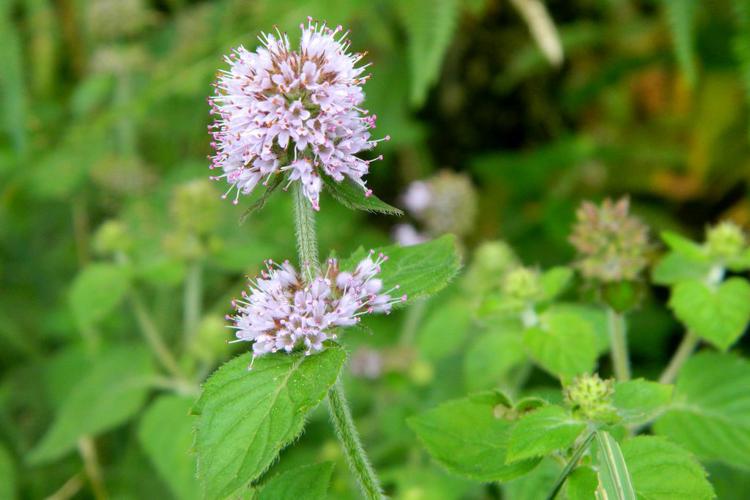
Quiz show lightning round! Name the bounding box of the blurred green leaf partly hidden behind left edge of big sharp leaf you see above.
[138,395,199,500]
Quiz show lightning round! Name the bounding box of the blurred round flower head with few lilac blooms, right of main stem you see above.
[393,170,478,246]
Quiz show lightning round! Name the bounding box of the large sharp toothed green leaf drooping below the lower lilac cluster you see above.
[194,346,346,498]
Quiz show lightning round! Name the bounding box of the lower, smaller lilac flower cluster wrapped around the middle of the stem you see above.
[227,252,406,358]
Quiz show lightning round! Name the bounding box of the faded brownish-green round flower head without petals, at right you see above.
[570,198,651,283]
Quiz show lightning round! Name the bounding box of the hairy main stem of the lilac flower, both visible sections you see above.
[294,183,385,500]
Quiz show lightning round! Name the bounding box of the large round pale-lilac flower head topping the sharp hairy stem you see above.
[209,19,388,210]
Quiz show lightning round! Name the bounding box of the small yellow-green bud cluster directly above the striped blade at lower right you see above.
[563,374,617,422]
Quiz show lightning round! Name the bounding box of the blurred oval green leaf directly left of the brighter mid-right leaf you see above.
[464,329,526,391]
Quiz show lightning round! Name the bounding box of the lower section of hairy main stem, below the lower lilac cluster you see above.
[328,380,385,500]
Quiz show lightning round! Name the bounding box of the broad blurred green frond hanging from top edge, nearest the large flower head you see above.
[399,0,460,107]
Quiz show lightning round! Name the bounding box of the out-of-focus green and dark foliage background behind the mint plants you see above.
[0,0,750,499]
